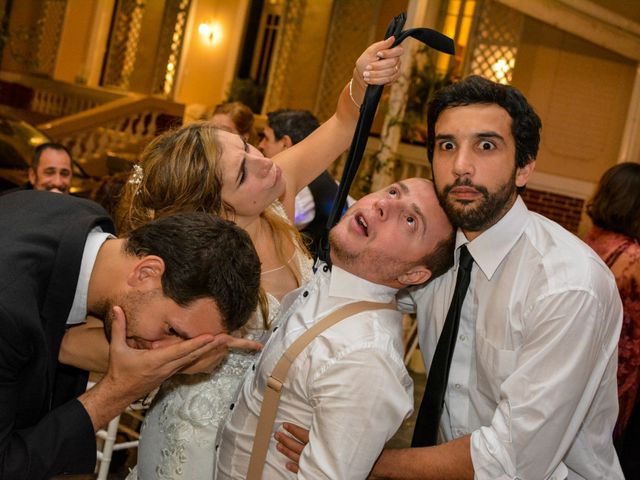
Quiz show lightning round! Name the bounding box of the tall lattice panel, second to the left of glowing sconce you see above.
[102,0,146,90]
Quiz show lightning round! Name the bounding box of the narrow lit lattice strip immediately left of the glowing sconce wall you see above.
[152,0,191,96]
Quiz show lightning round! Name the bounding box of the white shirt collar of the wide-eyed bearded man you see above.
[456,195,529,280]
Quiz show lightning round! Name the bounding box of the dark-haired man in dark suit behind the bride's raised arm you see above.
[258,109,353,256]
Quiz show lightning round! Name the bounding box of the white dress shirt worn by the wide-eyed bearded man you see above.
[404,197,623,480]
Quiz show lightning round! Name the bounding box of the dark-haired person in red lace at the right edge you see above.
[584,163,640,478]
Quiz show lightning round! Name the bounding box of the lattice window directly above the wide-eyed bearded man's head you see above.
[467,0,524,84]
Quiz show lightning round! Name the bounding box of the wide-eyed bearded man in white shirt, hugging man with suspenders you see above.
[284,76,623,480]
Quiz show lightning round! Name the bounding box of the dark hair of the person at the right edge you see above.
[587,162,640,240]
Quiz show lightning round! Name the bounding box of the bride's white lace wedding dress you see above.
[127,207,311,480]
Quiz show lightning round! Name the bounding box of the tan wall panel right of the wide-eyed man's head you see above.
[513,17,636,182]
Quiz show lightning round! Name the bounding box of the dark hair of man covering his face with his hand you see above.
[124,212,260,331]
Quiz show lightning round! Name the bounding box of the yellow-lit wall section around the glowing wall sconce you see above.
[174,0,248,107]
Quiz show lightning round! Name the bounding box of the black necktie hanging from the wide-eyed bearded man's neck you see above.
[411,245,473,447]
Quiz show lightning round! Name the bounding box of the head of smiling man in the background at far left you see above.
[28,142,73,193]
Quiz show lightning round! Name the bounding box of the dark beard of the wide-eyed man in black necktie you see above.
[436,174,516,232]
